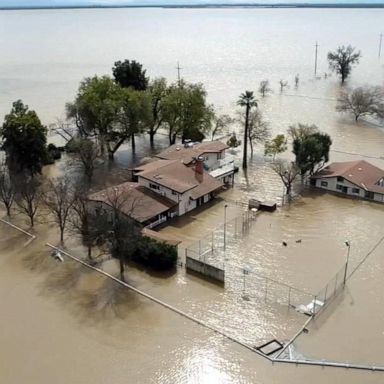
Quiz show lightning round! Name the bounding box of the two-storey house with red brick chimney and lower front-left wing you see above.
[89,149,224,228]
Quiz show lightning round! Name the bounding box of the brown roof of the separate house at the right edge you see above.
[313,160,384,193]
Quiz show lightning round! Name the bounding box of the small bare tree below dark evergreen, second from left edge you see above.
[15,176,42,227]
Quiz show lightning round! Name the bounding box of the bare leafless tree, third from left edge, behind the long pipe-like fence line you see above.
[44,177,74,243]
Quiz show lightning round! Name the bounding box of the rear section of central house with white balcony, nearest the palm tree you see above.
[156,140,237,185]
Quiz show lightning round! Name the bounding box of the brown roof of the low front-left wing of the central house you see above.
[88,182,177,223]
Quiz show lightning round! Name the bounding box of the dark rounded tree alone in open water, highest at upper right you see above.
[328,45,361,83]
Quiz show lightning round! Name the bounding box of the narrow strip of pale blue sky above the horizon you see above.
[0,0,384,7]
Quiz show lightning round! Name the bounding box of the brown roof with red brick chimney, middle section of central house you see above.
[135,160,223,200]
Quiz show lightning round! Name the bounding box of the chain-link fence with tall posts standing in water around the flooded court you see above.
[185,211,347,316]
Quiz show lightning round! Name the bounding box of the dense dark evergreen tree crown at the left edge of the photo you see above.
[0,100,47,176]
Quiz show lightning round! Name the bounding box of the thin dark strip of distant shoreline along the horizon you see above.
[0,3,384,11]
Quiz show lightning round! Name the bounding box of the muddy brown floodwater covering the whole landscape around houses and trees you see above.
[0,9,384,384]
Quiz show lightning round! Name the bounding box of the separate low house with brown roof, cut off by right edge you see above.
[311,160,384,203]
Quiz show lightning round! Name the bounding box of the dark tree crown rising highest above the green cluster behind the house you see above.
[112,60,148,91]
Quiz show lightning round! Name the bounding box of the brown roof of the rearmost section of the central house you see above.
[156,140,229,165]
